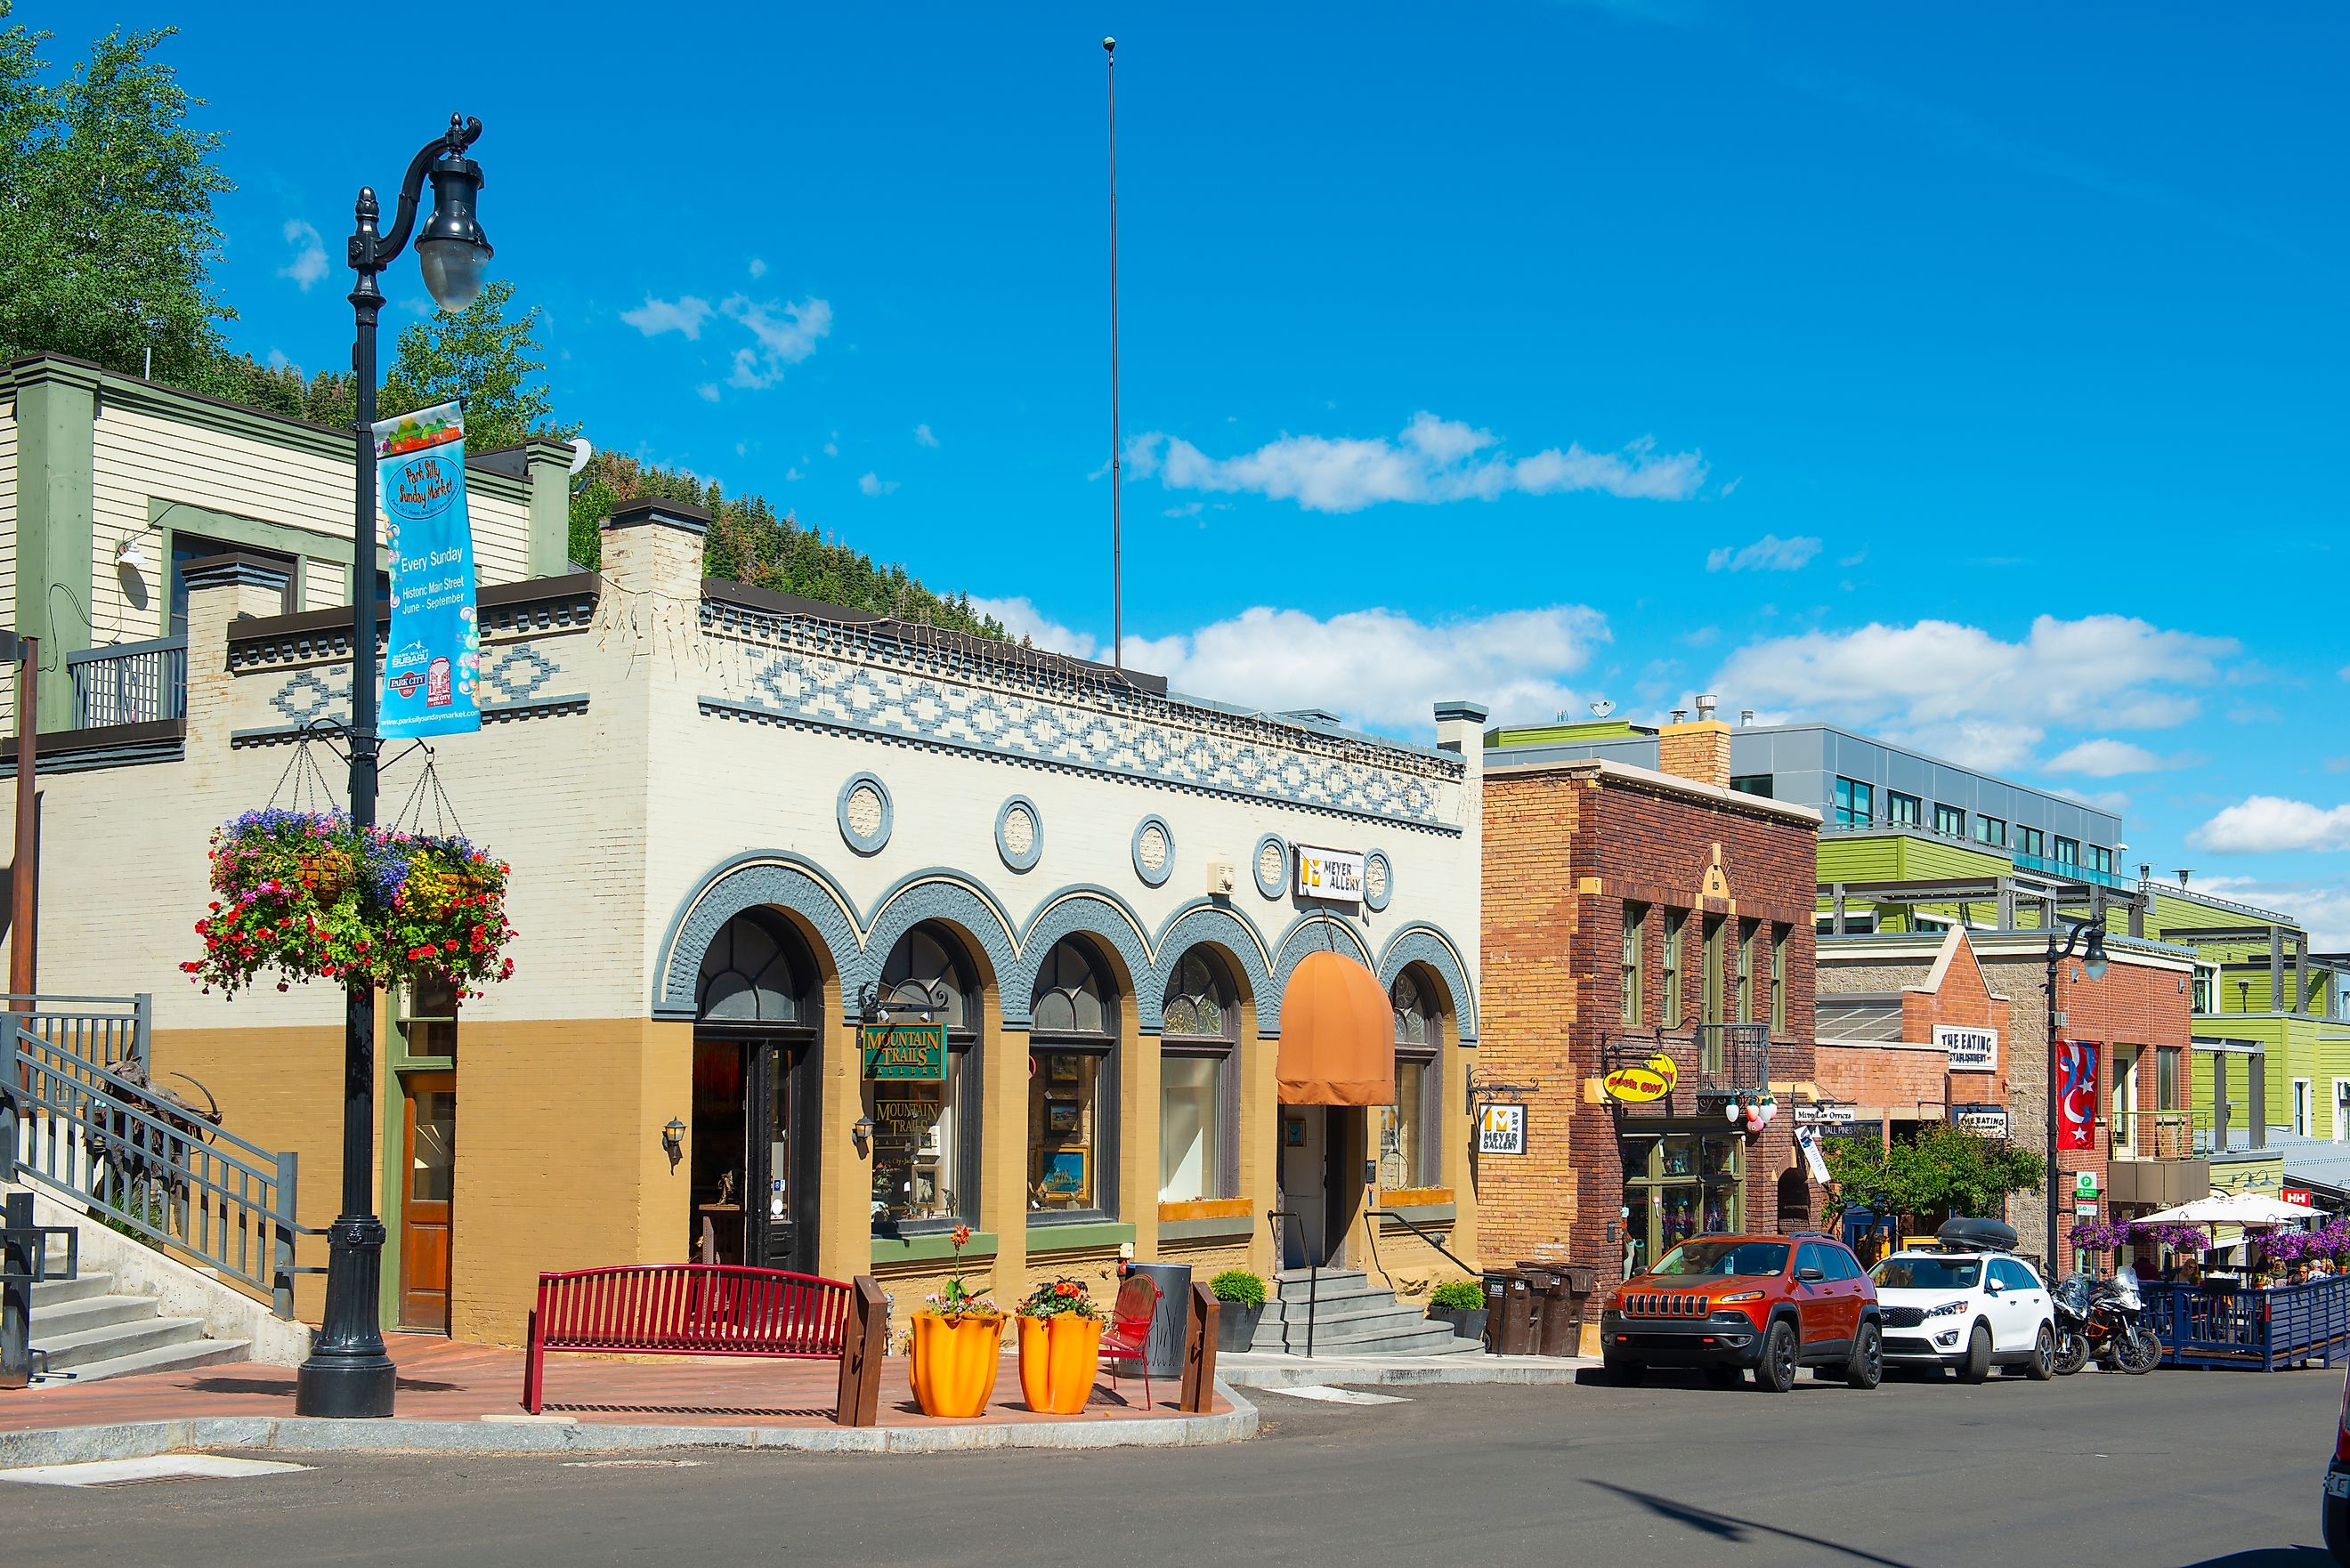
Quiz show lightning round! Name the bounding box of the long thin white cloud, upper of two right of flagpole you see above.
[1126,411,1706,513]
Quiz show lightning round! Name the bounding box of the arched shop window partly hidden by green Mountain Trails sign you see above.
[865,922,980,1237]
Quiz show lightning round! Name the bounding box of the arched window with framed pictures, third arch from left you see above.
[1029,935,1119,1223]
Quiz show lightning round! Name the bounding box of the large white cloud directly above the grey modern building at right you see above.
[1708,616,2237,769]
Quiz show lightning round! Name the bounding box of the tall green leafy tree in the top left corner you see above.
[0,0,235,388]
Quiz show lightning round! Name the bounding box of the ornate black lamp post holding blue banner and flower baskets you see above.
[294,115,491,1415]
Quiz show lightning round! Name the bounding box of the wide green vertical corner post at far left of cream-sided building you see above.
[12,364,96,733]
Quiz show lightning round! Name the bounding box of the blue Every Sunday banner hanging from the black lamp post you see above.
[376,402,482,736]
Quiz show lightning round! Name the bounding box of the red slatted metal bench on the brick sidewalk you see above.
[522,1263,853,1415]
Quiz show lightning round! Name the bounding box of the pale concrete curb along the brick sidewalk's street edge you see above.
[0,1380,1257,1469]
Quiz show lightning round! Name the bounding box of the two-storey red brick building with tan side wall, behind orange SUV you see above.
[1473,722,1819,1286]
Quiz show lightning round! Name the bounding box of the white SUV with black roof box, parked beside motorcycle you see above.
[1868,1246,2056,1382]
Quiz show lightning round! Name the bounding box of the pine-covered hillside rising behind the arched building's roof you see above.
[571,451,1009,642]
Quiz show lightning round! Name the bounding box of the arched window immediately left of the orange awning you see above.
[1159,948,1241,1204]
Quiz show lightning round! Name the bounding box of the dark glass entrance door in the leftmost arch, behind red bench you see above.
[691,1034,818,1274]
